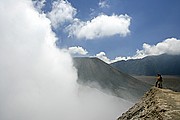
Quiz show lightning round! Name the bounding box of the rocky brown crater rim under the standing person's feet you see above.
[117,87,180,120]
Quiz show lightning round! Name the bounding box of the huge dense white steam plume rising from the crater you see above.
[0,0,132,120]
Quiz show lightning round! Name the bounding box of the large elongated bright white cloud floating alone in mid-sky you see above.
[67,15,131,39]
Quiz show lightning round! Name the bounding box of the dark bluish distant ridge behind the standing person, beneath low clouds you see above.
[111,54,180,75]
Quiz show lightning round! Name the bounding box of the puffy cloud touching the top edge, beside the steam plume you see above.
[48,0,77,28]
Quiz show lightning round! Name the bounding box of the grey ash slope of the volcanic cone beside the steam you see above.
[74,58,150,101]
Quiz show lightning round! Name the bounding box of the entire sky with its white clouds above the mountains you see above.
[34,0,180,63]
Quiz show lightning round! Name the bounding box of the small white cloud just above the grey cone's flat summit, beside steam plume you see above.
[68,46,88,55]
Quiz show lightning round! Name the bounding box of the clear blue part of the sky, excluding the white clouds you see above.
[34,0,180,60]
